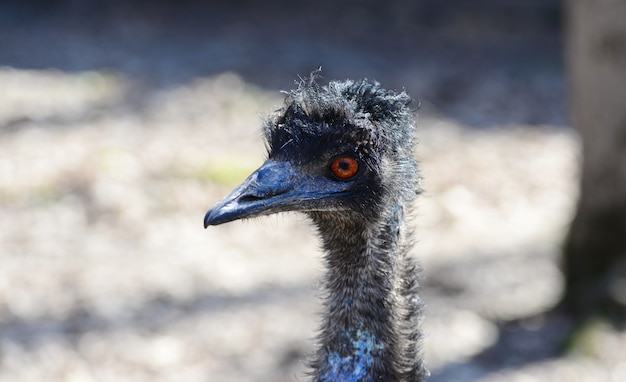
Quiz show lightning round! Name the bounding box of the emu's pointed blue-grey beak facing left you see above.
[204,159,317,228]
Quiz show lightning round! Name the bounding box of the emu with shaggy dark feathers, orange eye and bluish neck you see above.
[204,75,428,382]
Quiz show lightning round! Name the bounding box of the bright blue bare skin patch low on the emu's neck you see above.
[321,330,383,382]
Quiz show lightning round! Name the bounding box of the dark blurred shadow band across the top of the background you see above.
[0,0,564,126]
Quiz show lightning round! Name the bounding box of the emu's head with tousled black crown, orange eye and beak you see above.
[204,78,418,227]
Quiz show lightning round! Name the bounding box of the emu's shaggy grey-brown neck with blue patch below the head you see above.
[309,205,427,382]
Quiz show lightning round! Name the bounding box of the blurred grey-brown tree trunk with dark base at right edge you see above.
[561,0,626,320]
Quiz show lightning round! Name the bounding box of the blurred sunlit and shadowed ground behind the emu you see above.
[0,1,626,382]
